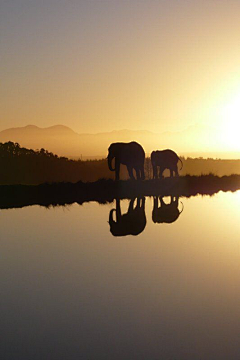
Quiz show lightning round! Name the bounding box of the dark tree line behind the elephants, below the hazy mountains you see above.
[0,141,240,185]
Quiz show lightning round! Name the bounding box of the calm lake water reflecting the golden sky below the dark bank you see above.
[0,192,240,360]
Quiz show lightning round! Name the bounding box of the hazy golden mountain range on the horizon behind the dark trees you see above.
[0,125,236,159]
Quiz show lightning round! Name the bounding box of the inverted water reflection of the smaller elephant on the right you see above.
[152,196,183,224]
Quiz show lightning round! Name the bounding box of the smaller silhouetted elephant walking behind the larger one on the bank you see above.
[151,150,183,179]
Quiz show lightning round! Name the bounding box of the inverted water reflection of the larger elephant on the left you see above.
[109,198,147,236]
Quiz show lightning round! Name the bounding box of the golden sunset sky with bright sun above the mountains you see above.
[0,0,240,148]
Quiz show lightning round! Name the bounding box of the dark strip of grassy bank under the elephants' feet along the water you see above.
[0,175,240,209]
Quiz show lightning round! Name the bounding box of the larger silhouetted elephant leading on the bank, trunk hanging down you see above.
[107,141,145,180]
